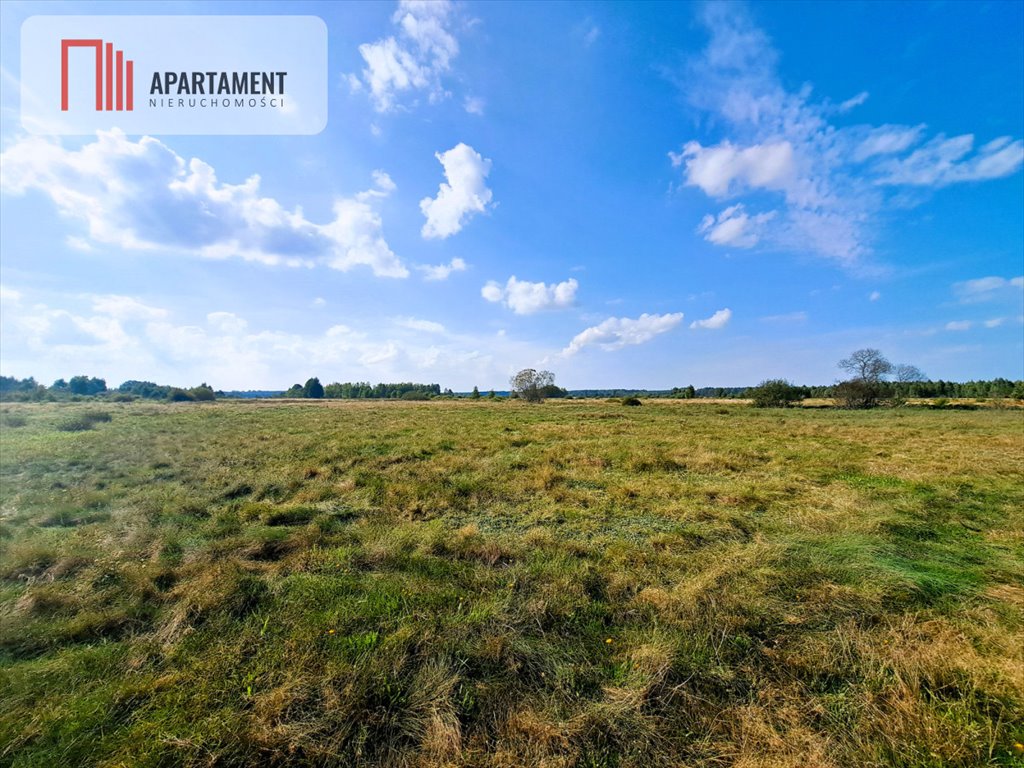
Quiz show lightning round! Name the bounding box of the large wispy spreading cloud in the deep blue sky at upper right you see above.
[669,3,1024,266]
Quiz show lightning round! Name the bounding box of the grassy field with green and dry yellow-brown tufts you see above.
[0,400,1024,768]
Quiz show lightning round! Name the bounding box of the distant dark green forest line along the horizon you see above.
[0,376,1024,402]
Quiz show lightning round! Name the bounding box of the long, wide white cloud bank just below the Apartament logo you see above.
[0,130,409,278]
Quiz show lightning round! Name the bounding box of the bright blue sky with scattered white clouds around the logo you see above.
[0,0,1024,391]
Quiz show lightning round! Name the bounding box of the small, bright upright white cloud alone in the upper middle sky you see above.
[420,142,493,239]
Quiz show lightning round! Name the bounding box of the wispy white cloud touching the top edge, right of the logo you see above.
[356,0,459,112]
